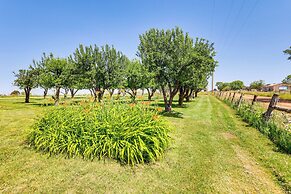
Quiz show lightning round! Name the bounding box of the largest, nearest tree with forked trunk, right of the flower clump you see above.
[137,28,197,111]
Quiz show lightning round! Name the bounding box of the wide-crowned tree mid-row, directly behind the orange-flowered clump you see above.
[70,45,127,102]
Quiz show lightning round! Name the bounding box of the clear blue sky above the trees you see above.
[0,0,291,94]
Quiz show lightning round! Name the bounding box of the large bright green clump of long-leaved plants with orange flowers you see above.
[29,103,169,165]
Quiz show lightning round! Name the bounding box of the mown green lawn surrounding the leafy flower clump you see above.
[0,95,291,193]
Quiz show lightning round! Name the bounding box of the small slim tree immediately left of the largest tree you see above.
[125,59,146,102]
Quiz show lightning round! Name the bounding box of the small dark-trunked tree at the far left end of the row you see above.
[13,69,37,103]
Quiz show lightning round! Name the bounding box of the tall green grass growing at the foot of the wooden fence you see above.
[224,95,291,154]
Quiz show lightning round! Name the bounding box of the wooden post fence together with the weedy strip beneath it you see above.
[215,92,291,154]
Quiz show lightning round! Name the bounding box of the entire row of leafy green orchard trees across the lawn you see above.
[14,27,217,111]
